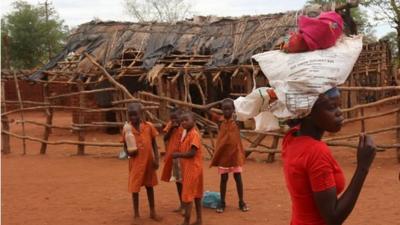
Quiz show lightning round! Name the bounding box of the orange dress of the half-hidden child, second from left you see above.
[161,122,183,182]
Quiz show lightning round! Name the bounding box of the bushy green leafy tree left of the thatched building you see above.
[1,1,67,68]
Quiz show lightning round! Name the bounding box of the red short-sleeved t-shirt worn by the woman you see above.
[282,128,345,225]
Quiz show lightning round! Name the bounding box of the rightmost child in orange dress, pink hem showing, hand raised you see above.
[211,99,249,213]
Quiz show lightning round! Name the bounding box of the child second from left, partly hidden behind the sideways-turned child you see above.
[161,109,183,212]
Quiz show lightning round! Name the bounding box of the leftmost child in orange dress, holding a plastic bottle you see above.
[123,103,161,221]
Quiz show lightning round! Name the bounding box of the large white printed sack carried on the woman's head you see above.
[252,36,362,119]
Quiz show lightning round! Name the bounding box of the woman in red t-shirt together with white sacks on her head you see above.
[235,33,376,225]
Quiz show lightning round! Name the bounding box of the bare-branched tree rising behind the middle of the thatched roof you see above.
[124,0,193,23]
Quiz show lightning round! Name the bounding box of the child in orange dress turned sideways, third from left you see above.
[172,112,203,225]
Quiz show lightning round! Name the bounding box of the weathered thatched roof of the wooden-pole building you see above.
[31,12,296,79]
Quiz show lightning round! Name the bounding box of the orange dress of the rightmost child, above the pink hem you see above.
[210,115,245,168]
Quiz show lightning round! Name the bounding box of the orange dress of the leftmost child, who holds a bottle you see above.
[122,122,158,193]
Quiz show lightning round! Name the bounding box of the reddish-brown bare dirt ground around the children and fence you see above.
[1,108,400,225]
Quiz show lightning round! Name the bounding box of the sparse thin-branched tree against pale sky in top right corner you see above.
[364,0,400,63]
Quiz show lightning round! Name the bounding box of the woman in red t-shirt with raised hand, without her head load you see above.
[282,88,375,225]
